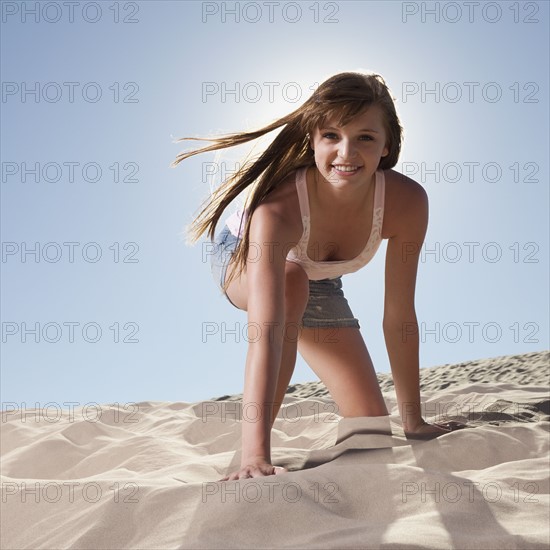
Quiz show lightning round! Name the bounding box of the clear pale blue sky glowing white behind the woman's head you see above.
[0,0,550,408]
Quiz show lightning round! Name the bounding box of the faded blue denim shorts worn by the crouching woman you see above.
[210,226,360,328]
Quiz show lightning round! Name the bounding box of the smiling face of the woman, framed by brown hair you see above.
[310,105,389,185]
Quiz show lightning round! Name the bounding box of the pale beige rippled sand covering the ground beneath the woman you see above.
[0,352,550,550]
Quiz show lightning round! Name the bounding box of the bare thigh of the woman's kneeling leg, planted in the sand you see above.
[298,327,388,417]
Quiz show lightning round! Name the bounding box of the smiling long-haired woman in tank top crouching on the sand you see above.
[172,73,462,480]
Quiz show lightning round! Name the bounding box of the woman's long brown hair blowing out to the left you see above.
[170,72,403,289]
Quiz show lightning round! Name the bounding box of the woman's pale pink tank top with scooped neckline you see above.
[226,166,385,281]
